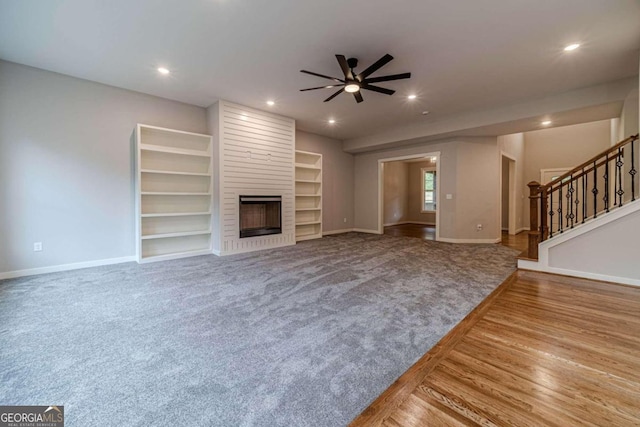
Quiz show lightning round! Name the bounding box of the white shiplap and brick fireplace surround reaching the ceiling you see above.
[207,100,295,255]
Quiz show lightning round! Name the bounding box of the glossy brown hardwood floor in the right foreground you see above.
[351,271,640,427]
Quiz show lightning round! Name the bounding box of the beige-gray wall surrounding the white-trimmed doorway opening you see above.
[354,137,500,240]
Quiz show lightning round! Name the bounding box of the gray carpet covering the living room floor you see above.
[0,233,517,427]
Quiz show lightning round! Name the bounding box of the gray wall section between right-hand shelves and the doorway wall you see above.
[296,130,356,233]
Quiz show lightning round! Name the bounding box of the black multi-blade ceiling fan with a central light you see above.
[300,53,411,103]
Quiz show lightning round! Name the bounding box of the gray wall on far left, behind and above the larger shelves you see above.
[0,61,207,272]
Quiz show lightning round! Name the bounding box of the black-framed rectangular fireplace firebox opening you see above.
[240,196,282,239]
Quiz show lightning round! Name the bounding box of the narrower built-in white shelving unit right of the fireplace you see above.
[295,150,322,241]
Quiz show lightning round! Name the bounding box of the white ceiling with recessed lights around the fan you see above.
[0,0,640,143]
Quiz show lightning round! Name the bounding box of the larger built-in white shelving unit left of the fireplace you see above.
[136,124,212,262]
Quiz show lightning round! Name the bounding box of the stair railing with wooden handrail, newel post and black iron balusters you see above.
[527,134,640,259]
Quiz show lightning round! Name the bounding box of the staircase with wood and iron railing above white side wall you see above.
[518,135,640,285]
